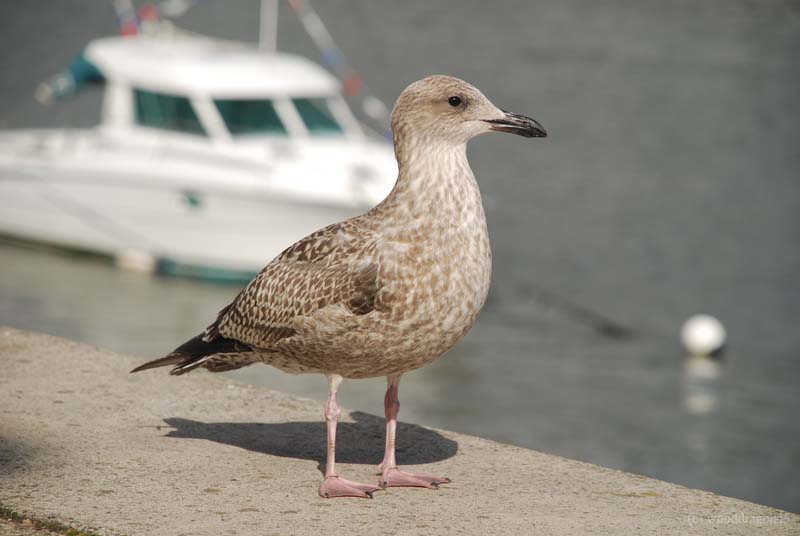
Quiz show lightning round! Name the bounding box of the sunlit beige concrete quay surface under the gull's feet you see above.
[0,327,800,536]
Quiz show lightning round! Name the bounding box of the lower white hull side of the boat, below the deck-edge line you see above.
[0,165,372,278]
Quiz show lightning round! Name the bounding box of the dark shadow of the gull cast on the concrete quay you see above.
[164,411,458,470]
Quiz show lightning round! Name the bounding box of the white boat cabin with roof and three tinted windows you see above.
[85,35,364,144]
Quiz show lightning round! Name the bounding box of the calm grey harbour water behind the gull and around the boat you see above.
[0,0,800,511]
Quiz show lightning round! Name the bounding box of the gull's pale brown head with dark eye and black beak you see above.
[392,75,547,144]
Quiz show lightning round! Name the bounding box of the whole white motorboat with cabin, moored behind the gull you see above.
[0,34,397,277]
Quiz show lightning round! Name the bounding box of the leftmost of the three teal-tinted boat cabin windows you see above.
[133,89,206,134]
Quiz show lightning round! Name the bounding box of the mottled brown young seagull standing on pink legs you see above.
[131,75,547,498]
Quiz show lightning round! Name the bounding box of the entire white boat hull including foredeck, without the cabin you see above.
[0,130,396,278]
